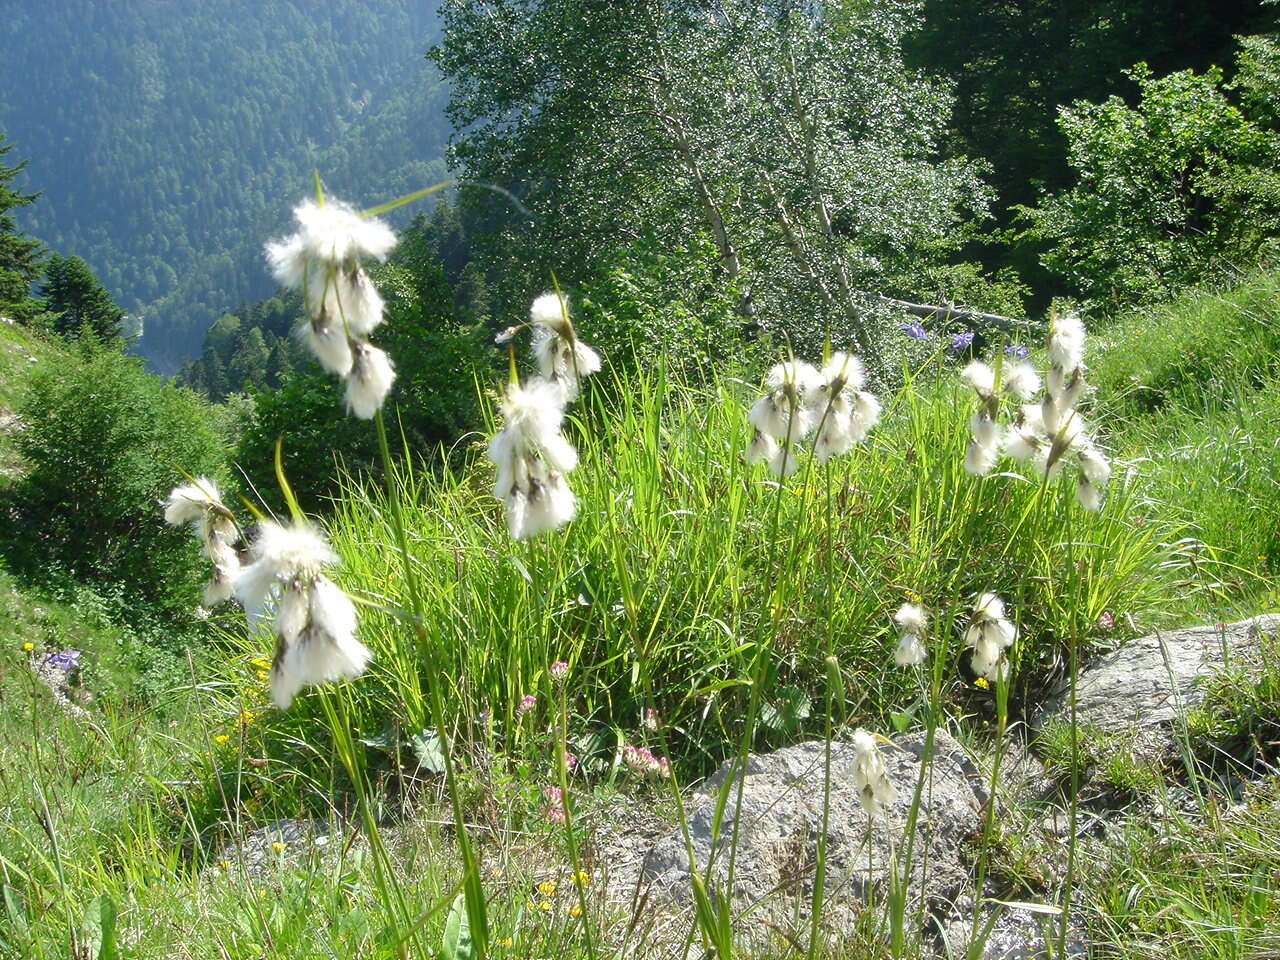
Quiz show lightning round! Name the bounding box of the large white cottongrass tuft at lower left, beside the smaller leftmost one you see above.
[234,521,372,709]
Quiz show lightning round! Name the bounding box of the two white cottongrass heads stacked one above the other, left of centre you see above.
[489,293,600,540]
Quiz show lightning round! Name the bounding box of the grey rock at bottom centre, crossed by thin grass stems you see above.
[641,731,986,937]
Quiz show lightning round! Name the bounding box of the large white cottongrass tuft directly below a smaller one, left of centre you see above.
[489,380,577,540]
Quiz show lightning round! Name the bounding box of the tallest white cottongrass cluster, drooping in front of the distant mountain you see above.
[266,200,396,420]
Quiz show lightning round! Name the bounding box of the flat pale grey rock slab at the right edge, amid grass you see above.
[1033,613,1280,759]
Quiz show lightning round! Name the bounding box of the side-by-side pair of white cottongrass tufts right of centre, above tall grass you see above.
[746,353,881,476]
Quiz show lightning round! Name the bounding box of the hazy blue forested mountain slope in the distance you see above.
[0,0,448,371]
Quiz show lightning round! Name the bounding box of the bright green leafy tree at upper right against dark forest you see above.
[1024,64,1280,307]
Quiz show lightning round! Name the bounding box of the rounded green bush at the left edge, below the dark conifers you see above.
[5,347,224,609]
